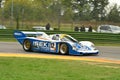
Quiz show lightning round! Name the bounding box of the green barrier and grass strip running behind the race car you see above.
[0,30,120,46]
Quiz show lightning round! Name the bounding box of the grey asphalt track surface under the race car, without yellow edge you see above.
[0,42,120,62]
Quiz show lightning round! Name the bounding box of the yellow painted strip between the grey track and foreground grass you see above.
[0,53,120,64]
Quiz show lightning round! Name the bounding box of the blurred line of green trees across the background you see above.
[0,0,120,27]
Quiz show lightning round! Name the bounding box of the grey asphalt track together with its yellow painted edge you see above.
[0,42,120,64]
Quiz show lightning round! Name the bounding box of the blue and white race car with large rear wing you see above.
[14,31,99,55]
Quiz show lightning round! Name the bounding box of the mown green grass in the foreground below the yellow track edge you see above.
[0,57,120,80]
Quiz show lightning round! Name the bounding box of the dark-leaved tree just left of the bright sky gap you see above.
[89,0,109,20]
